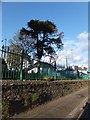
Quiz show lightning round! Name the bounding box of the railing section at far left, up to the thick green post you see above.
[0,48,21,79]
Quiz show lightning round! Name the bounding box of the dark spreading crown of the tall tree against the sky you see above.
[13,20,63,61]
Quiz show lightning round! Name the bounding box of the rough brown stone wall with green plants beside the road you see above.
[2,80,88,119]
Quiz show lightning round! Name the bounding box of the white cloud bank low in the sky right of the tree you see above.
[57,32,88,66]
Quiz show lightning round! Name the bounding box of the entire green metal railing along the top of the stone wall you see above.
[0,47,88,80]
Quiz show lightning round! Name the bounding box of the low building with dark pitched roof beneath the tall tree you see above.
[28,61,56,79]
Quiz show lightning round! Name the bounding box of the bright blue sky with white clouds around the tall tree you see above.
[2,2,88,66]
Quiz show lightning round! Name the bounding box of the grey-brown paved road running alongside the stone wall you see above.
[13,88,88,118]
